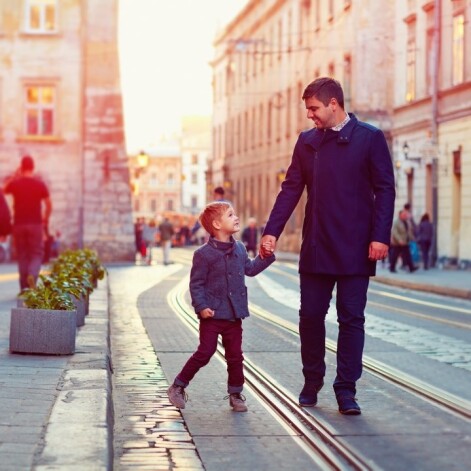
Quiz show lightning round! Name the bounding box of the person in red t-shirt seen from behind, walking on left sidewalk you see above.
[4,155,52,291]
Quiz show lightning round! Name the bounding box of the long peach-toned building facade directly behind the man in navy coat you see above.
[212,0,394,250]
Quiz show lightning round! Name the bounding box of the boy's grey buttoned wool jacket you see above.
[190,237,275,320]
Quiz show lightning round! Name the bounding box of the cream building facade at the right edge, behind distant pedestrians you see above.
[393,0,471,268]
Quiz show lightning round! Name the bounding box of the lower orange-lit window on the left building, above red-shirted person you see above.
[25,85,56,136]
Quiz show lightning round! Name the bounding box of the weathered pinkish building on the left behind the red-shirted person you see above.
[0,0,134,261]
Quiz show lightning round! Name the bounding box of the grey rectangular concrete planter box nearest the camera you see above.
[10,307,77,355]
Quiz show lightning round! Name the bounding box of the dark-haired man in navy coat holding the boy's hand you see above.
[259,78,395,415]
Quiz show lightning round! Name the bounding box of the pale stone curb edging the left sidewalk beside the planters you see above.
[34,277,113,471]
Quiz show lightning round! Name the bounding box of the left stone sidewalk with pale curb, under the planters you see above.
[0,264,112,471]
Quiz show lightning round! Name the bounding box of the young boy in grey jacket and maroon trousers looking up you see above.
[167,201,275,412]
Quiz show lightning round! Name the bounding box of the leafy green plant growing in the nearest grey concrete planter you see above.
[20,275,75,311]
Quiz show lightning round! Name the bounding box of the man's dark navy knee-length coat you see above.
[264,114,395,276]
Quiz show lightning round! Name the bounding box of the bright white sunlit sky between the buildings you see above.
[119,0,247,152]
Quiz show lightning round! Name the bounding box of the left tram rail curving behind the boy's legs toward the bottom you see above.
[167,278,376,471]
